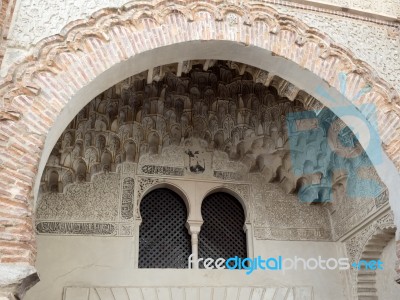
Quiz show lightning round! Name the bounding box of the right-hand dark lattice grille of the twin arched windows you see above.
[199,193,247,268]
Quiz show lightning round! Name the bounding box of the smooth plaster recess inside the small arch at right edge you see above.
[376,238,400,300]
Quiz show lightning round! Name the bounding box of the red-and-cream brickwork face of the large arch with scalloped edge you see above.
[0,1,400,290]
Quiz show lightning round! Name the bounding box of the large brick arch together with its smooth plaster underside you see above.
[0,1,400,290]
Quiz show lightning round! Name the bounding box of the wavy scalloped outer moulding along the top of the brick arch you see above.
[0,1,399,161]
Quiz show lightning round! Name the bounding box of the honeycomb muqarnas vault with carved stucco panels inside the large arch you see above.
[38,61,387,240]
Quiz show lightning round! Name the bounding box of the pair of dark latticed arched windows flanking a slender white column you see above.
[139,188,247,268]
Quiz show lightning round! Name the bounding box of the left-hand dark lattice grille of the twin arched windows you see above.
[139,189,191,268]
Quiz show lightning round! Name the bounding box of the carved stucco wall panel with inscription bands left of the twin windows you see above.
[36,173,134,236]
